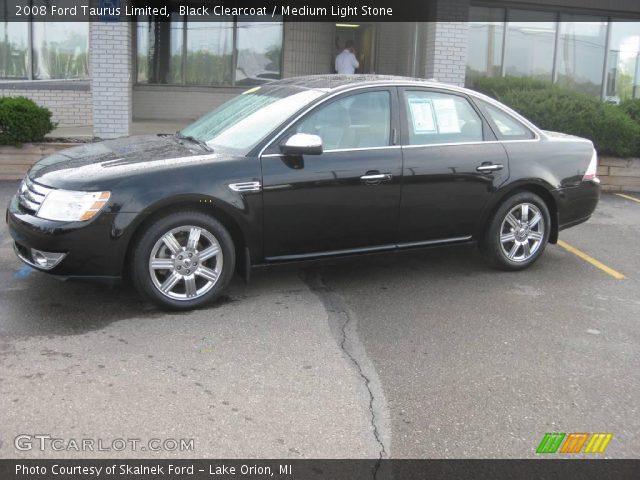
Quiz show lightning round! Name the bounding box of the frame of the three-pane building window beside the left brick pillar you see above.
[132,15,285,88]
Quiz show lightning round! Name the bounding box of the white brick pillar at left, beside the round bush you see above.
[89,21,133,138]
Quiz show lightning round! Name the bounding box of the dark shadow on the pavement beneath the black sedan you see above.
[0,245,524,336]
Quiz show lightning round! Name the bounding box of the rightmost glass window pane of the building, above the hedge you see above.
[605,19,640,102]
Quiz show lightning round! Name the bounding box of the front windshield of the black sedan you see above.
[180,86,324,152]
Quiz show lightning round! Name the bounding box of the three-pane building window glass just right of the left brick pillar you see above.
[136,14,283,86]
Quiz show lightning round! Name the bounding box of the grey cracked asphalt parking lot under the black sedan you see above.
[0,182,640,458]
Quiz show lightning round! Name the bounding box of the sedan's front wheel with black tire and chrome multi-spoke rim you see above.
[131,211,235,310]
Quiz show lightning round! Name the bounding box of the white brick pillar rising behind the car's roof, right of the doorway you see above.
[424,0,469,86]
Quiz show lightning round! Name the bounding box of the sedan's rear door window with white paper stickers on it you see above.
[404,90,483,145]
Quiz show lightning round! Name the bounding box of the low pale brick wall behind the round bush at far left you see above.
[0,86,93,127]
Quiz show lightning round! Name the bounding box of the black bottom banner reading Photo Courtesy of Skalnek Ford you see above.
[0,459,640,480]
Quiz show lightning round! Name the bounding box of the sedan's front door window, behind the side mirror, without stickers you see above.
[296,90,391,151]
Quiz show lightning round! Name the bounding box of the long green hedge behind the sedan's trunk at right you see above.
[473,77,640,157]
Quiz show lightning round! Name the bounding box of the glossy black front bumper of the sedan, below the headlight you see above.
[6,196,126,278]
